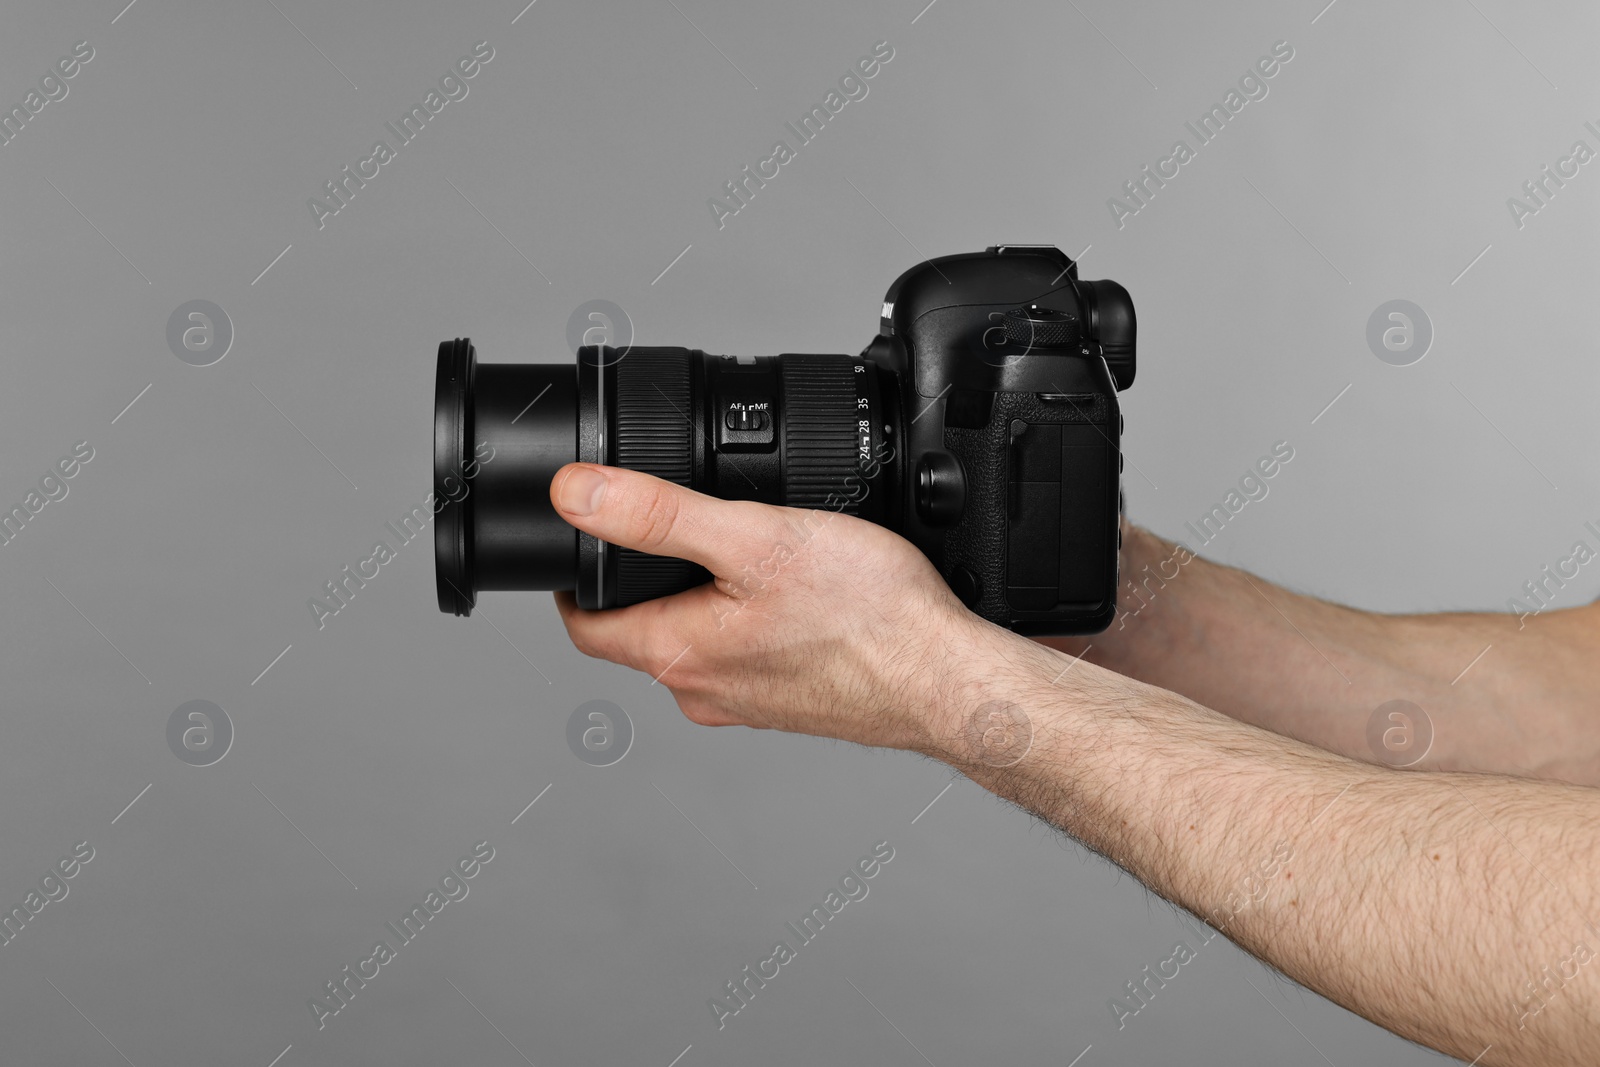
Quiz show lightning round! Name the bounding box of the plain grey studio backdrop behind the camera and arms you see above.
[0,0,1600,1067]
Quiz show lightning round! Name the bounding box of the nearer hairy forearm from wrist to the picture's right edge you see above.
[931,632,1600,1064]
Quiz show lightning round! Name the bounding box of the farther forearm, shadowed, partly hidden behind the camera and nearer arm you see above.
[1046,526,1600,784]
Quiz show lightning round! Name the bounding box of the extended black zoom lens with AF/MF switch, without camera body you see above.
[434,338,899,614]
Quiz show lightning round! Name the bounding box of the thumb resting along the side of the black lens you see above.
[550,464,790,574]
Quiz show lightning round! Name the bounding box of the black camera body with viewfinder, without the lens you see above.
[864,245,1136,633]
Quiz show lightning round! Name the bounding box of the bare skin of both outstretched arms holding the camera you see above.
[550,464,1600,1064]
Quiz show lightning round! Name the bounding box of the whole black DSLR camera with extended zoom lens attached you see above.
[434,245,1136,635]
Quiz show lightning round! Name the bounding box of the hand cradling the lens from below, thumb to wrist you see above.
[550,464,994,750]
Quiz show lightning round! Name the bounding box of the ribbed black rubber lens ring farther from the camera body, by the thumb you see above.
[610,349,710,608]
